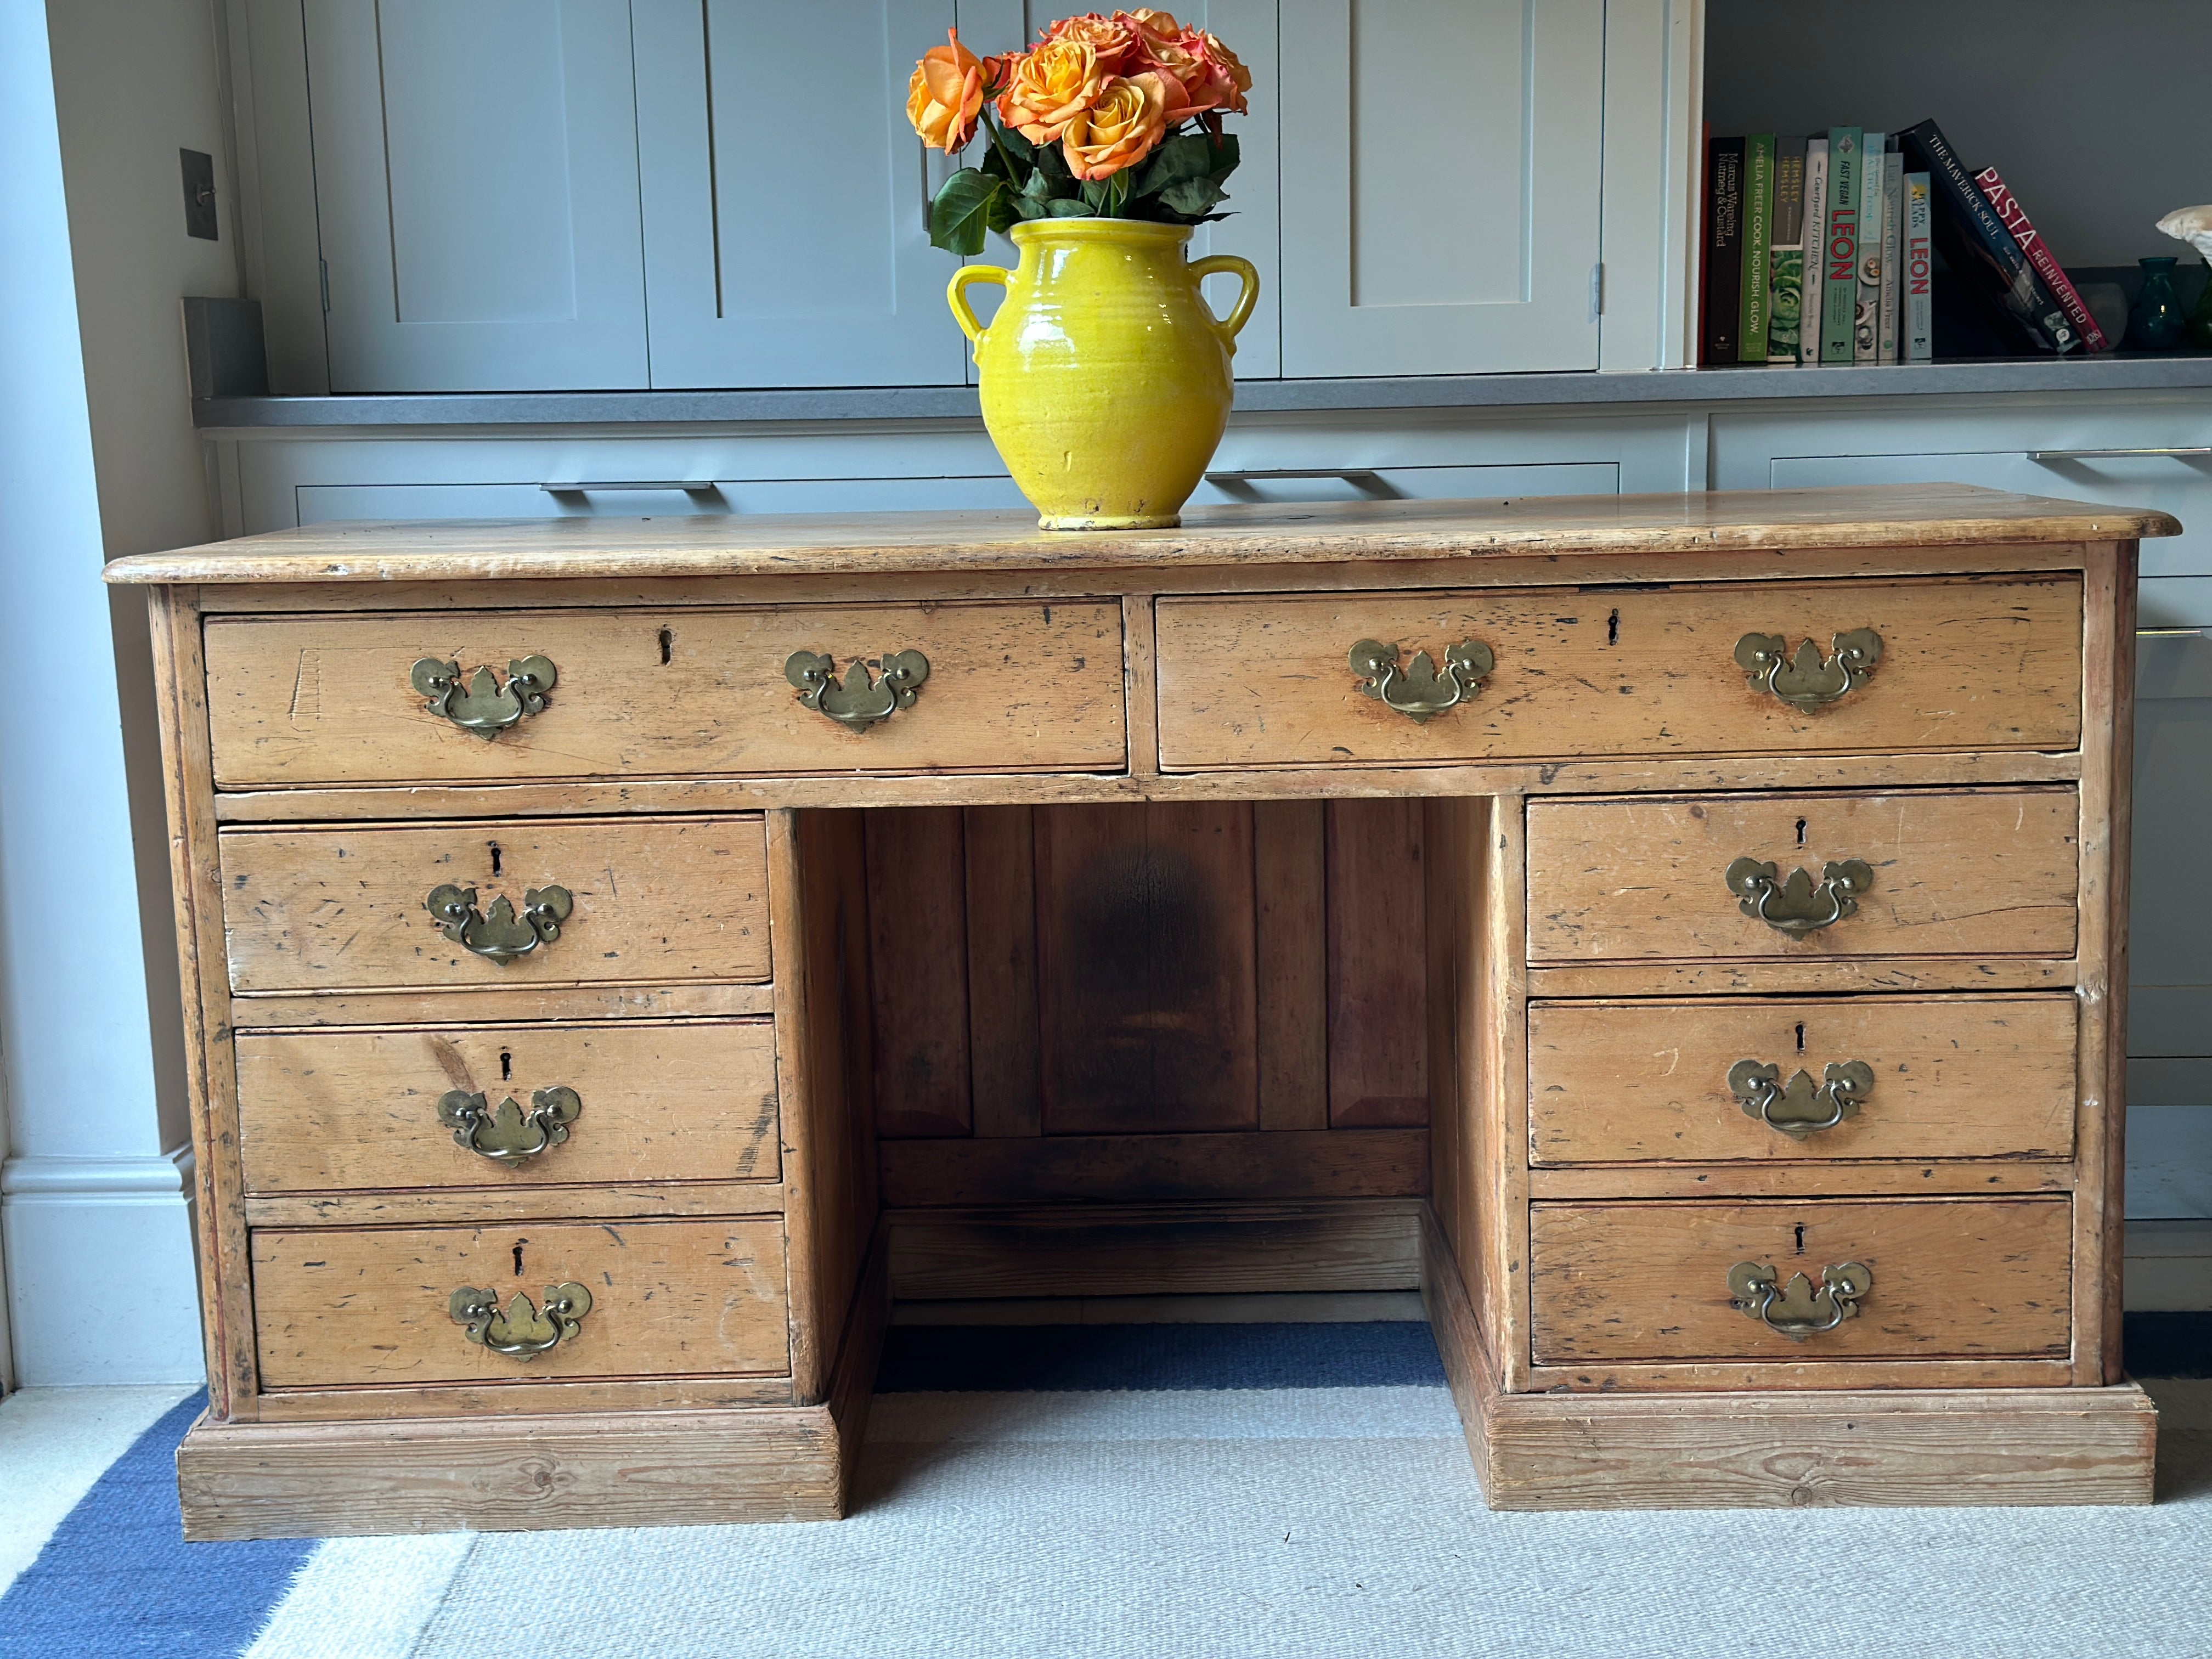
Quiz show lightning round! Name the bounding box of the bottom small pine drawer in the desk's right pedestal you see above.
[1528,1197,2073,1365]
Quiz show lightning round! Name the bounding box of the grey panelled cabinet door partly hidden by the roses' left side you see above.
[630,0,964,387]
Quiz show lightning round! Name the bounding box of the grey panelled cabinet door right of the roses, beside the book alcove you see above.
[1281,0,1606,376]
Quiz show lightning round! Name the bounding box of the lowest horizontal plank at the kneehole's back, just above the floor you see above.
[885,1199,1420,1301]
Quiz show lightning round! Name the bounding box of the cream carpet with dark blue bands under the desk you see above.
[0,1323,2212,1659]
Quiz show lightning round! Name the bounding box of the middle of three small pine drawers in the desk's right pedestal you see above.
[1528,995,2077,1166]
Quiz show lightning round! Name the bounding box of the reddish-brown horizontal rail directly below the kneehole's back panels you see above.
[881,1128,1429,1207]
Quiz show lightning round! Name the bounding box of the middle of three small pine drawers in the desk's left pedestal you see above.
[236,1020,778,1192]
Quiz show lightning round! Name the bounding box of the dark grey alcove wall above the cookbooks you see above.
[1706,0,2212,266]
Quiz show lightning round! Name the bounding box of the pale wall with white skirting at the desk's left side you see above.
[0,0,236,1385]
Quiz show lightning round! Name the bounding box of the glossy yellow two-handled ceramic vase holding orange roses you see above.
[945,219,1259,531]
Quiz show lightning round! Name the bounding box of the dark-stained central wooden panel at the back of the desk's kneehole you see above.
[1037,803,1259,1135]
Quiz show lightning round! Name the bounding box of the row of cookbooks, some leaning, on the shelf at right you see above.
[1699,122,2108,367]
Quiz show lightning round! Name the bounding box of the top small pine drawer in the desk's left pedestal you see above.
[219,816,768,995]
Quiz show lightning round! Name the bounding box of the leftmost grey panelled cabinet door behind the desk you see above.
[305,0,646,392]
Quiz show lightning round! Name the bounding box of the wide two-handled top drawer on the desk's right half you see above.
[1159,575,2081,768]
